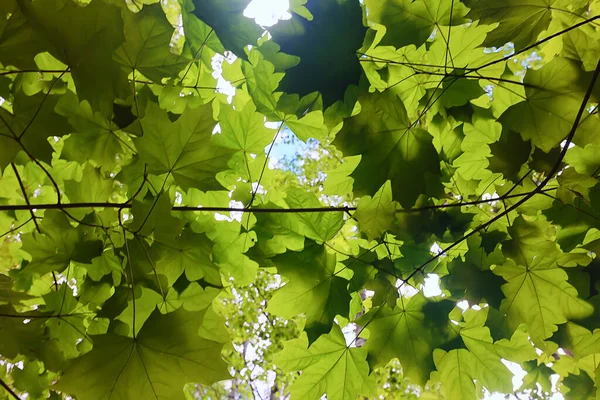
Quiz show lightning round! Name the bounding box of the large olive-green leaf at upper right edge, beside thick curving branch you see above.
[500,57,600,152]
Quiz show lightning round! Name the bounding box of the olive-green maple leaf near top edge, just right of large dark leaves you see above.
[113,4,191,82]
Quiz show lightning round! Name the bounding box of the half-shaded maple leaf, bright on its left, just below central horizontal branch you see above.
[267,244,350,341]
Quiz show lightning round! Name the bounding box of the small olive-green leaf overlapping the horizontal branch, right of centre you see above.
[353,181,396,240]
